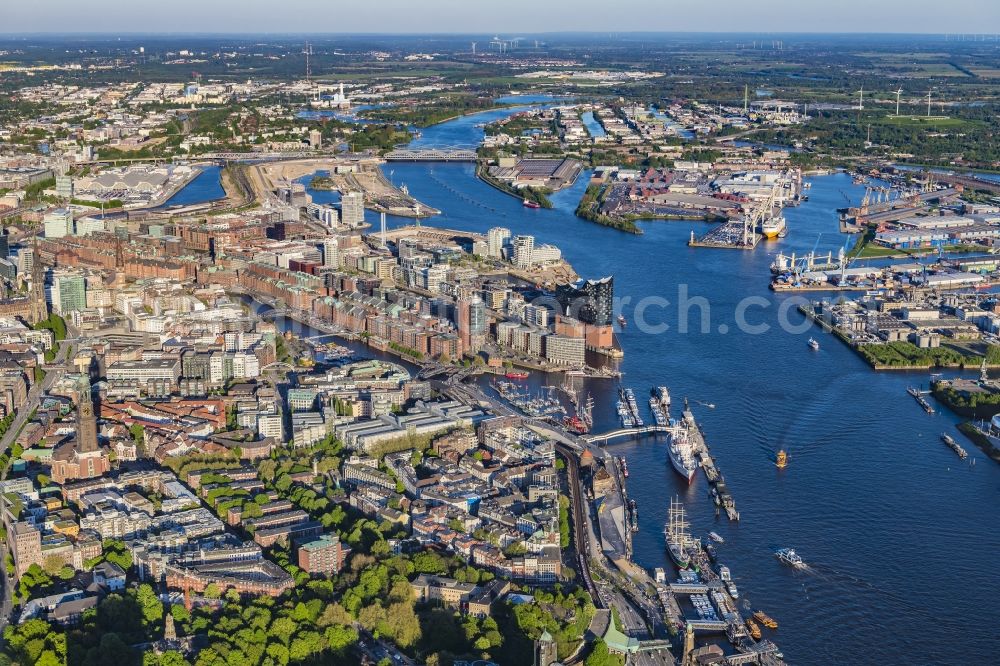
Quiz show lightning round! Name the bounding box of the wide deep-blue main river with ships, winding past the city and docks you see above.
[197,101,1000,665]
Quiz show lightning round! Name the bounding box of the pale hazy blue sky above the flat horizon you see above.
[0,0,1000,34]
